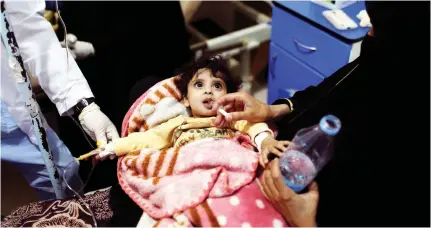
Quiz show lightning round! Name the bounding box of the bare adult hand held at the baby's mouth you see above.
[212,91,270,127]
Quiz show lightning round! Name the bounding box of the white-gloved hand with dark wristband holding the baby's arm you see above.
[78,103,119,145]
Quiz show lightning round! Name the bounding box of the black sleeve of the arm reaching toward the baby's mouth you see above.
[273,58,359,118]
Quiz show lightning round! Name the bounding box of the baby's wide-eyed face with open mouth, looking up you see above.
[184,69,227,117]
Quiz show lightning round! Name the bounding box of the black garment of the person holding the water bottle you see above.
[278,2,430,226]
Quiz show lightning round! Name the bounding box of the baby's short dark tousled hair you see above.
[174,55,241,97]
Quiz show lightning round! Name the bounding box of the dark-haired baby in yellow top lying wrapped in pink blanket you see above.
[98,56,289,166]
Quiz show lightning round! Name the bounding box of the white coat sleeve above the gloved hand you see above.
[5,0,93,115]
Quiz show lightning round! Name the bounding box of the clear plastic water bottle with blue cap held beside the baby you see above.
[280,115,341,192]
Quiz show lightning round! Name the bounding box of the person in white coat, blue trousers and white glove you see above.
[0,0,118,199]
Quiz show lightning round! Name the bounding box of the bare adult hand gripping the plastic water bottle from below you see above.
[261,158,319,227]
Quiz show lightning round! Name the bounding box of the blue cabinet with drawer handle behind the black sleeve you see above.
[268,1,369,103]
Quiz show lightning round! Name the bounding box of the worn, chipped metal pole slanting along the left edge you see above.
[0,0,65,199]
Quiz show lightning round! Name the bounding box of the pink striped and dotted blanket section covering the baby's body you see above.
[118,136,287,226]
